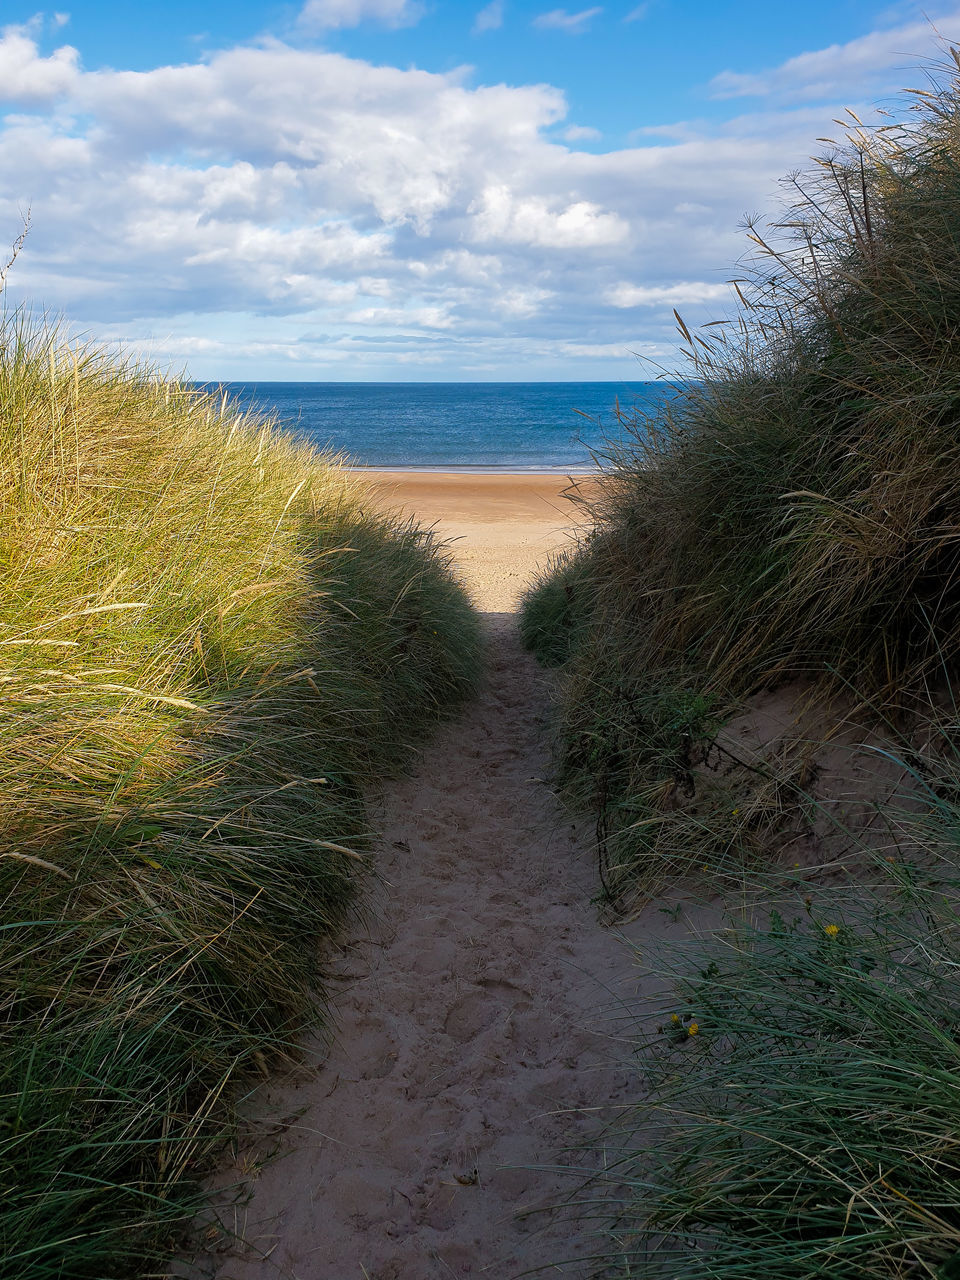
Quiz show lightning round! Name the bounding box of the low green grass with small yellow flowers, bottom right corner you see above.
[581,845,960,1280]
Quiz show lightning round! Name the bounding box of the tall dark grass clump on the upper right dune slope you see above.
[522,55,960,906]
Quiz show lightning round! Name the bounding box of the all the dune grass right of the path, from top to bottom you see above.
[522,51,960,1280]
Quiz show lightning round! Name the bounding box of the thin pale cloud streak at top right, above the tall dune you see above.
[709,9,960,101]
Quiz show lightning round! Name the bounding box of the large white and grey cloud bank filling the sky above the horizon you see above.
[0,16,947,378]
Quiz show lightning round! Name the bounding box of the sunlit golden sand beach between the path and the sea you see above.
[355,471,591,613]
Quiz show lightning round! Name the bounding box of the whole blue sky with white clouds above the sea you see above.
[0,0,960,381]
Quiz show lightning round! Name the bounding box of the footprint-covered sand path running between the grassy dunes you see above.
[181,478,647,1280]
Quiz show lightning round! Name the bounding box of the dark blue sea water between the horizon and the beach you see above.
[195,381,675,471]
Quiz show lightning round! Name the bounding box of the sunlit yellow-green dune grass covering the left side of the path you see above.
[0,316,479,1280]
